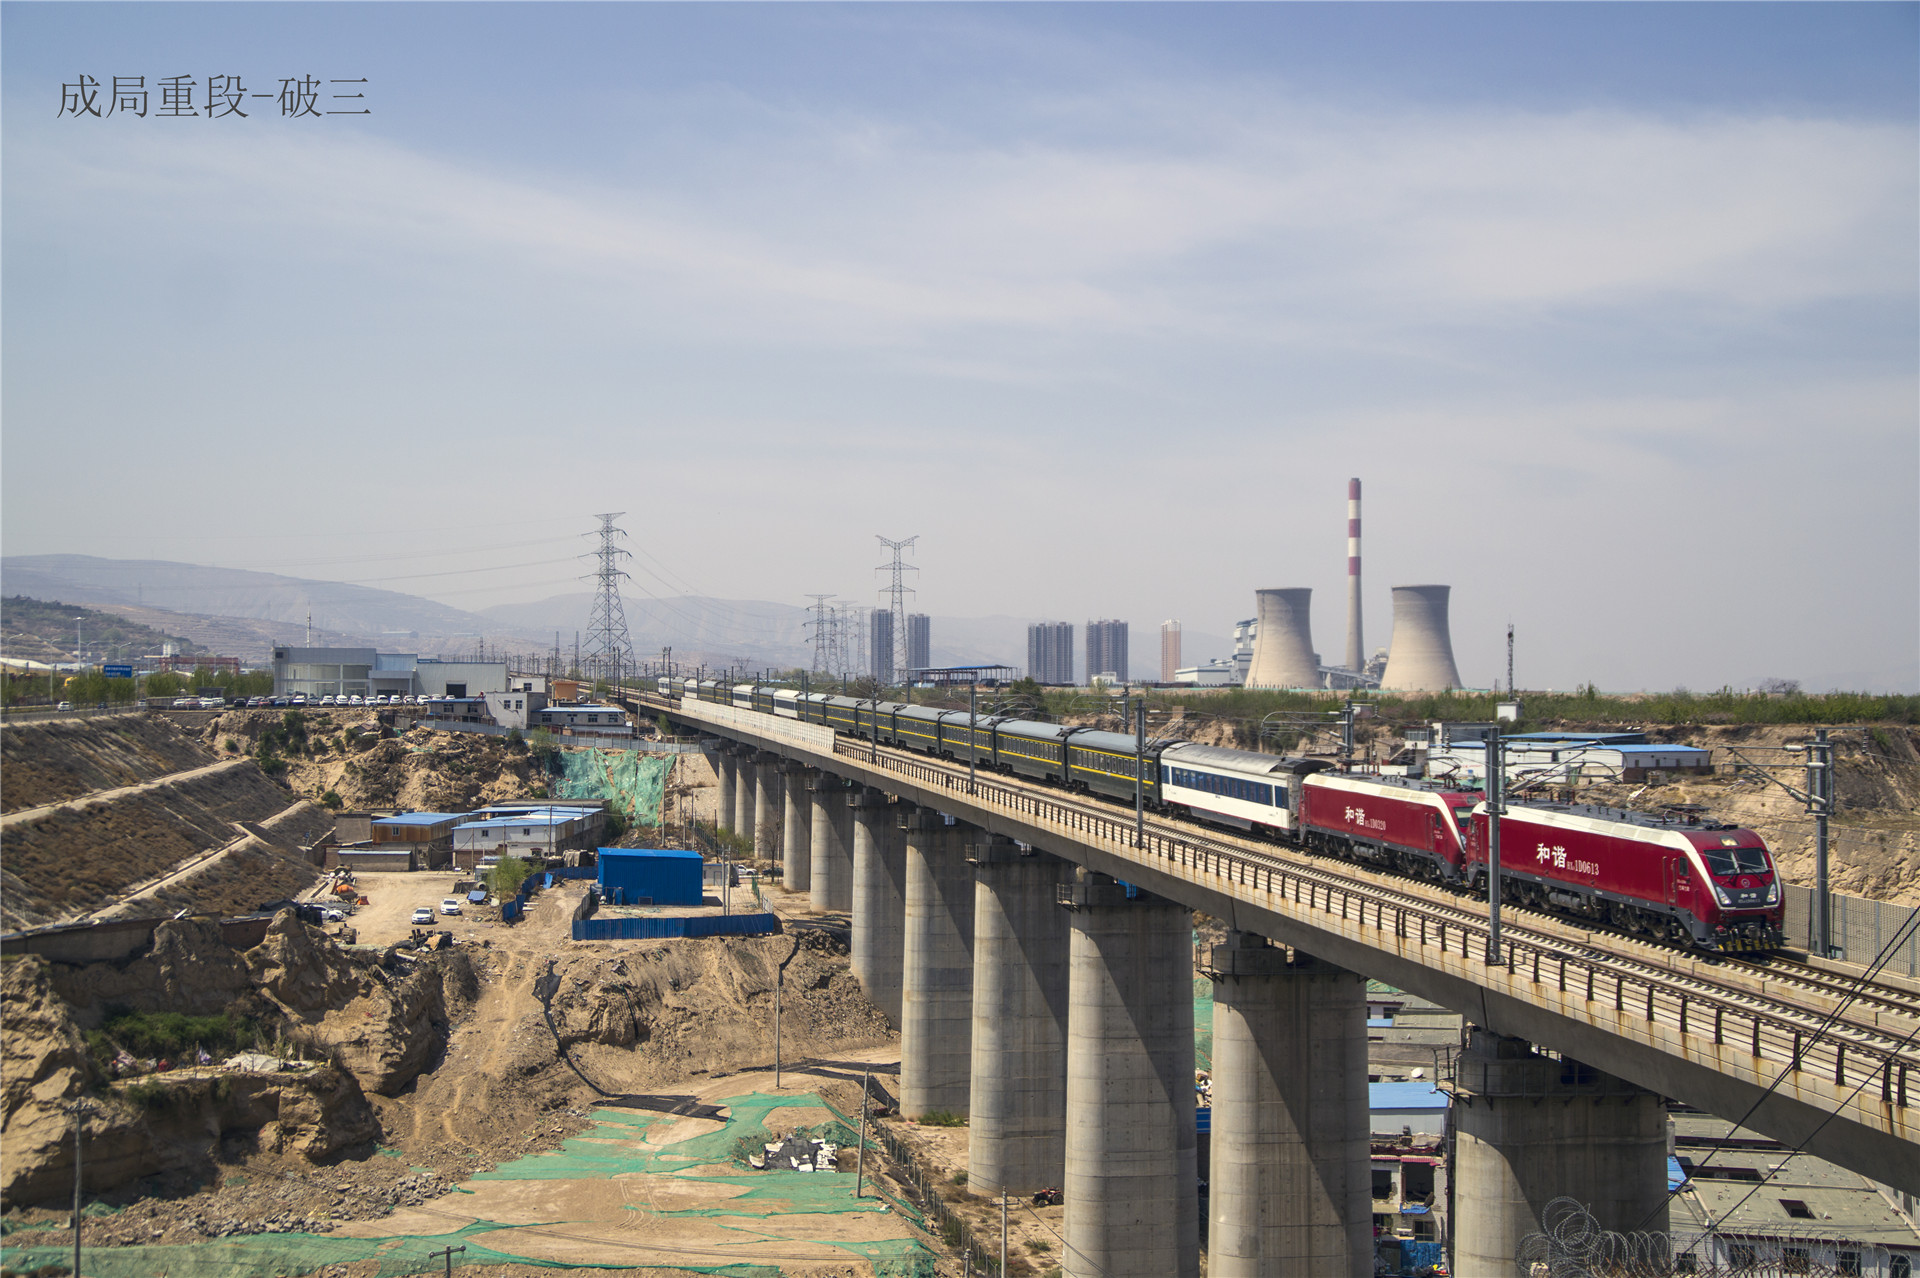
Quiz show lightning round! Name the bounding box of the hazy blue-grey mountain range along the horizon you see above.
[0,555,1233,677]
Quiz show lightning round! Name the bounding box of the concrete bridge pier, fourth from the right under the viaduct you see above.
[968,835,1073,1194]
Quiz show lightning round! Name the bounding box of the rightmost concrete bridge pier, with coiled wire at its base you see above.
[1453,1029,1667,1274]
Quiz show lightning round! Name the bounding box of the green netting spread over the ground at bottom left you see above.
[0,1094,937,1278]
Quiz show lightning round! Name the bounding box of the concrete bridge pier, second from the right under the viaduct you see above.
[1208,933,1374,1278]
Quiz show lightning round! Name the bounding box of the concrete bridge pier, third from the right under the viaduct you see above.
[1062,869,1200,1278]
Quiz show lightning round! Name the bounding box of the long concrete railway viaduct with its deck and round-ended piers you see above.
[637,695,1920,1278]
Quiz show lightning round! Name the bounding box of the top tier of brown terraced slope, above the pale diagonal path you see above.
[0,714,215,812]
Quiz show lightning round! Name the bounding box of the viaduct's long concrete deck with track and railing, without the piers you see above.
[641,697,1920,1192]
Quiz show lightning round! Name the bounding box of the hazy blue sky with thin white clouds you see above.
[0,2,1920,691]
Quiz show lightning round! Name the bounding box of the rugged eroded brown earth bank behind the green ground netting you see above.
[0,885,893,1274]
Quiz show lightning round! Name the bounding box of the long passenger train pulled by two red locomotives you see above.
[659,677,1786,950]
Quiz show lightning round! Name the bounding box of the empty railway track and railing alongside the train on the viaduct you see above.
[639,695,1920,1126]
